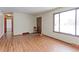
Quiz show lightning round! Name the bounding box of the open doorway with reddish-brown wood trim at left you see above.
[4,13,13,35]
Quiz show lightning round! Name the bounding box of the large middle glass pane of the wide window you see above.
[60,10,75,35]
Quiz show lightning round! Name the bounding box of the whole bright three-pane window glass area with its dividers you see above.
[54,9,79,36]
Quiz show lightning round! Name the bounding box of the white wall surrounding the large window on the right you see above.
[37,8,79,45]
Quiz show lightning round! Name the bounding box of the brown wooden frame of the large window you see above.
[53,8,79,37]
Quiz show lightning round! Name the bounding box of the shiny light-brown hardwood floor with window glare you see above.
[0,34,79,52]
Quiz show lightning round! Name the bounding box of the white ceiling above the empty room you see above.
[0,7,57,14]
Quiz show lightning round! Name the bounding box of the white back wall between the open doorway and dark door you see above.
[13,13,36,35]
